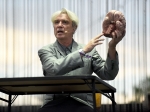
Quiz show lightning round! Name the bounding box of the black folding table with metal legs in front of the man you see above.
[0,76,116,112]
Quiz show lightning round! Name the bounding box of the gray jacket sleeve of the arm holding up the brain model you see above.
[92,50,119,80]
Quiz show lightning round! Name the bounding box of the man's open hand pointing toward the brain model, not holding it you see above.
[83,33,104,53]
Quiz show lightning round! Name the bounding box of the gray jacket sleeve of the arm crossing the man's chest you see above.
[38,48,83,76]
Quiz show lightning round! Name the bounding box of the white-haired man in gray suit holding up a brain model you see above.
[38,9,122,112]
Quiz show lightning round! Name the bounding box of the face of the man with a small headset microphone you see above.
[53,13,76,40]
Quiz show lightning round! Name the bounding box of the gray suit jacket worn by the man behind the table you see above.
[38,41,119,105]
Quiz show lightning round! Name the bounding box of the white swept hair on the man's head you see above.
[51,8,79,26]
